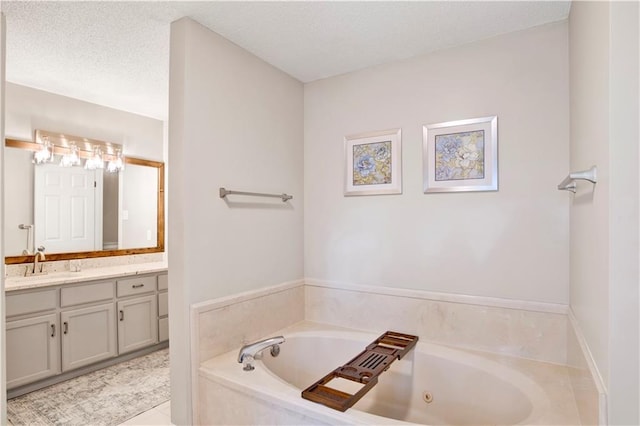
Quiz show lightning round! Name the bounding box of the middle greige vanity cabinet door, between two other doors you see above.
[60,303,117,371]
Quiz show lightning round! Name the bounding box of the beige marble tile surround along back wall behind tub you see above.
[305,282,567,364]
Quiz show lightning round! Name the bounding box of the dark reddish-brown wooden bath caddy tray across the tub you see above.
[302,331,418,411]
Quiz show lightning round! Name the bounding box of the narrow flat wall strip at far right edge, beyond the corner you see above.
[609,2,640,424]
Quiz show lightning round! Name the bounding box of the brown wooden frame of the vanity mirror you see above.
[3,138,164,265]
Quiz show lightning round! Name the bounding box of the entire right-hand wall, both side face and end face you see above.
[569,2,640,424]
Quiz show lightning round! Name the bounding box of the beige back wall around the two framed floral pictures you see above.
[304,22,569,304]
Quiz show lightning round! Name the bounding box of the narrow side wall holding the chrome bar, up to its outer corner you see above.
[569,2,609,390]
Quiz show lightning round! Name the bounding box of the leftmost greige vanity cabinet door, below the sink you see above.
[6,314,60,389]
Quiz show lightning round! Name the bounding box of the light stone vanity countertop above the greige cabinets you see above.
[4,262,167,292]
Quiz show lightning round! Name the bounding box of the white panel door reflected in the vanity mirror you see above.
[34,164,102,253]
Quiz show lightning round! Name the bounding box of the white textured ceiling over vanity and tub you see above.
[0,1,570,120]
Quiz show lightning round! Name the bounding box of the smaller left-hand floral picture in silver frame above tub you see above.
[344,128,402,196]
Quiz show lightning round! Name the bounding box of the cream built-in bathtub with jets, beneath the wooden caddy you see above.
[199,327,575,425]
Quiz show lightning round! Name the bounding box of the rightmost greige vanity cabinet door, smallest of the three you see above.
[118,294,158,354]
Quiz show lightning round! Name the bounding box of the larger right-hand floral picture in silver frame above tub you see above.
[422,115,498,194]
